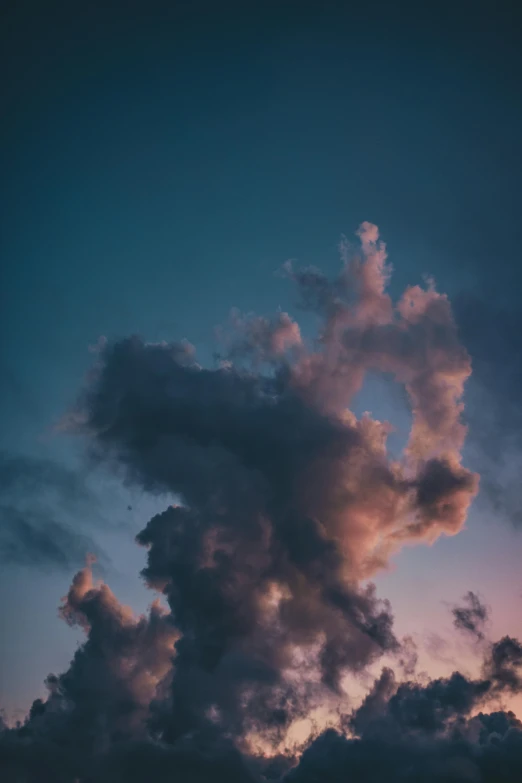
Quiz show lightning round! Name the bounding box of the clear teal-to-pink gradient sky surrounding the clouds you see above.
[0,0,522,728]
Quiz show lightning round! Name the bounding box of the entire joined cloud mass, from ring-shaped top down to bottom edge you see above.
[4,223,510,783]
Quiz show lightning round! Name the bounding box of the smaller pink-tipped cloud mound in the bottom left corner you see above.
[0,564,179,781]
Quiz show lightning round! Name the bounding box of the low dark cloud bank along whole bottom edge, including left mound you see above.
[6,620,522,783]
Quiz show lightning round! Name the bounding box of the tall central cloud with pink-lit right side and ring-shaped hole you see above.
[65,223,476,742]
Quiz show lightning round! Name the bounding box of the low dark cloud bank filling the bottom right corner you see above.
[285,637,522,783]
